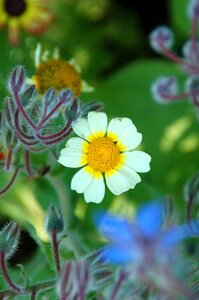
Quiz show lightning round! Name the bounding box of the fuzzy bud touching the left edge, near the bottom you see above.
[0,222,20,259]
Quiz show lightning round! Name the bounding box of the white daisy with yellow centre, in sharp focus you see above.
[58,111,151,203]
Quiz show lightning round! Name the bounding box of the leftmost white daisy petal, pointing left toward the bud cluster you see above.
[58,148,83,168]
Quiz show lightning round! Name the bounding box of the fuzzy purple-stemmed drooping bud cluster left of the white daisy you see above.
[0,66,102,189]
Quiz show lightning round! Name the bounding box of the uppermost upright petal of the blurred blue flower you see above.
[136,202,164,237]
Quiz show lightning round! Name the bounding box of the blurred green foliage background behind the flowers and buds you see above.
[0,0,199,299]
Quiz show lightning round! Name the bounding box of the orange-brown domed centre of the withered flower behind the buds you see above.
[33,59,81,96]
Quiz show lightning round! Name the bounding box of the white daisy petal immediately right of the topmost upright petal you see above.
[107,118,133,141]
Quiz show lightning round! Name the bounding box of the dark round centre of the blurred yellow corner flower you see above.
[4,0,26,17]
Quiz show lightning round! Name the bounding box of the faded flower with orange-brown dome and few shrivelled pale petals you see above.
[32,44,93,97]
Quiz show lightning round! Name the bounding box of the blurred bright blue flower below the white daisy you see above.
[97,201,194,265]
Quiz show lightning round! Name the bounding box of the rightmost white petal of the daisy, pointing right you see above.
[125,150,151,173]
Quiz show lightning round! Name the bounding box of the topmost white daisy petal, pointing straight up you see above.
[88,111,108,136]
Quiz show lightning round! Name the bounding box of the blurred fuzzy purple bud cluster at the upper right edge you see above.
[149,0,199,107]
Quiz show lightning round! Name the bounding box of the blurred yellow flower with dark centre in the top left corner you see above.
[0,0,52,45]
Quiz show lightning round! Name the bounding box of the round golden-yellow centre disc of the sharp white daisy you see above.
[87,137,120,172]
